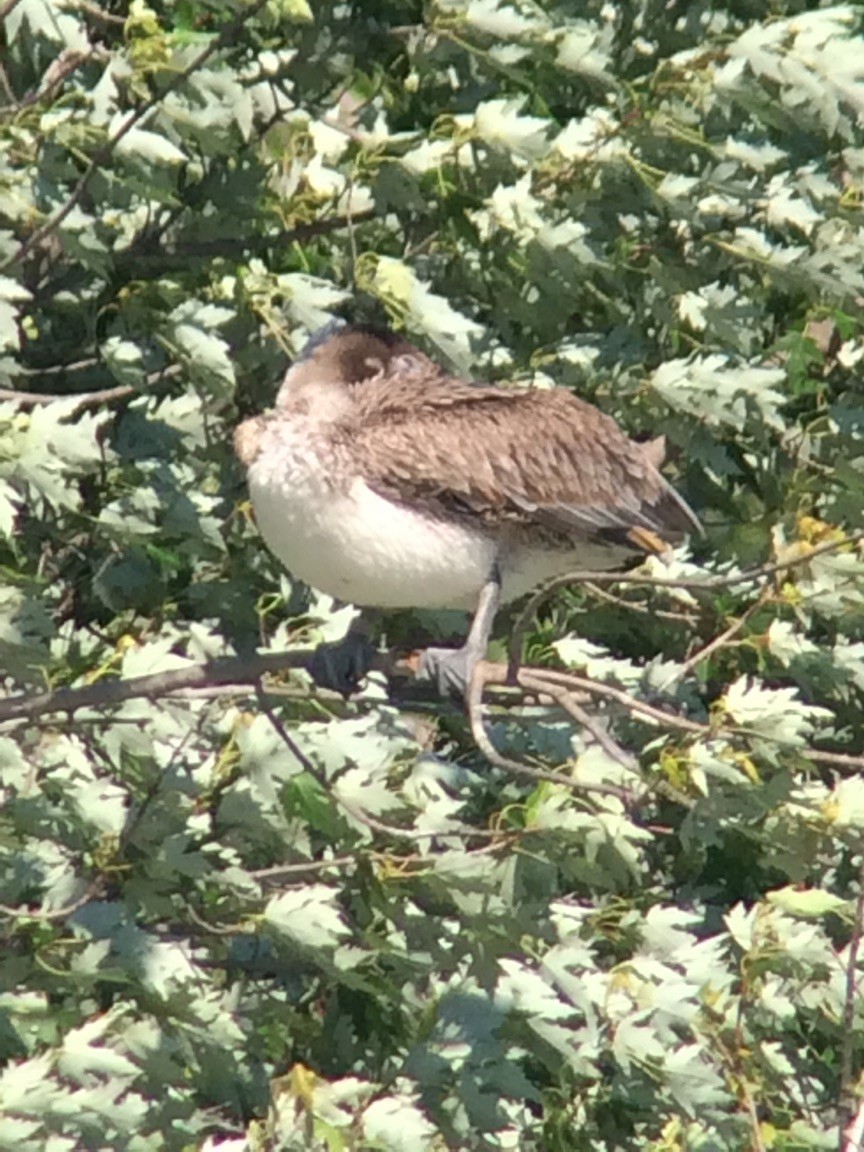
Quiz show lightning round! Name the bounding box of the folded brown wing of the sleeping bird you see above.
[351,373,700,552]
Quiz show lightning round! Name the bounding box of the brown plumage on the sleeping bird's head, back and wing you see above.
[245,327,700,553]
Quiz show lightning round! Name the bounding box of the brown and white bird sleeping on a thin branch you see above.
[234,320,702,696]
